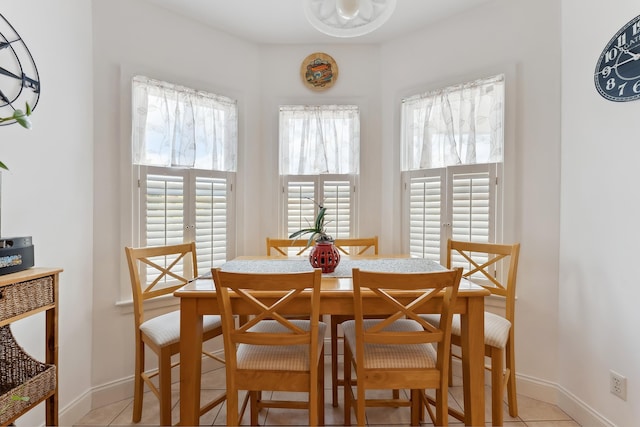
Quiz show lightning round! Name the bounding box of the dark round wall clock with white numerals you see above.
[594,15,640,102]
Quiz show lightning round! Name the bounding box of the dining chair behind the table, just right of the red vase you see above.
[330,236,378,406]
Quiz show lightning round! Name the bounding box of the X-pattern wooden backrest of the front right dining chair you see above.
[353,268,462,369]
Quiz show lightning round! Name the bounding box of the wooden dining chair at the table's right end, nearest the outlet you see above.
[424,239,520,425]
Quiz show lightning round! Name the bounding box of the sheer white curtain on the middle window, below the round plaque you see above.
[280,105,360,175]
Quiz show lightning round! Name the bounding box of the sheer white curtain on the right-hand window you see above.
[402,75,504,170]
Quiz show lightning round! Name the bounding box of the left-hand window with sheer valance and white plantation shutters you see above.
[132,76,238,272]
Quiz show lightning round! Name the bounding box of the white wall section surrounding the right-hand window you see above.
[381,0,560,394]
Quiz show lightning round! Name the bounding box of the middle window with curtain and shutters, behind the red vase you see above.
[280,105,360,251]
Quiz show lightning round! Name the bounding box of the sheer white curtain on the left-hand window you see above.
[132,76,238,171]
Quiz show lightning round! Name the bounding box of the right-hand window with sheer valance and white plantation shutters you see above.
[402,75,504,262]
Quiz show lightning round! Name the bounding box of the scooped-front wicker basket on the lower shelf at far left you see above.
[0,325,56,425]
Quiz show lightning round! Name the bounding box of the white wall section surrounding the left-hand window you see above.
[92,0,263,406]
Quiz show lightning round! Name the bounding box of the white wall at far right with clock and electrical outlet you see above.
[558,0,640,426]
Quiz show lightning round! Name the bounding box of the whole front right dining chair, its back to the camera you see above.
[342,268,462,425]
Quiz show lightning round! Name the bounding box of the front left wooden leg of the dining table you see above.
[180,298,203,426]
